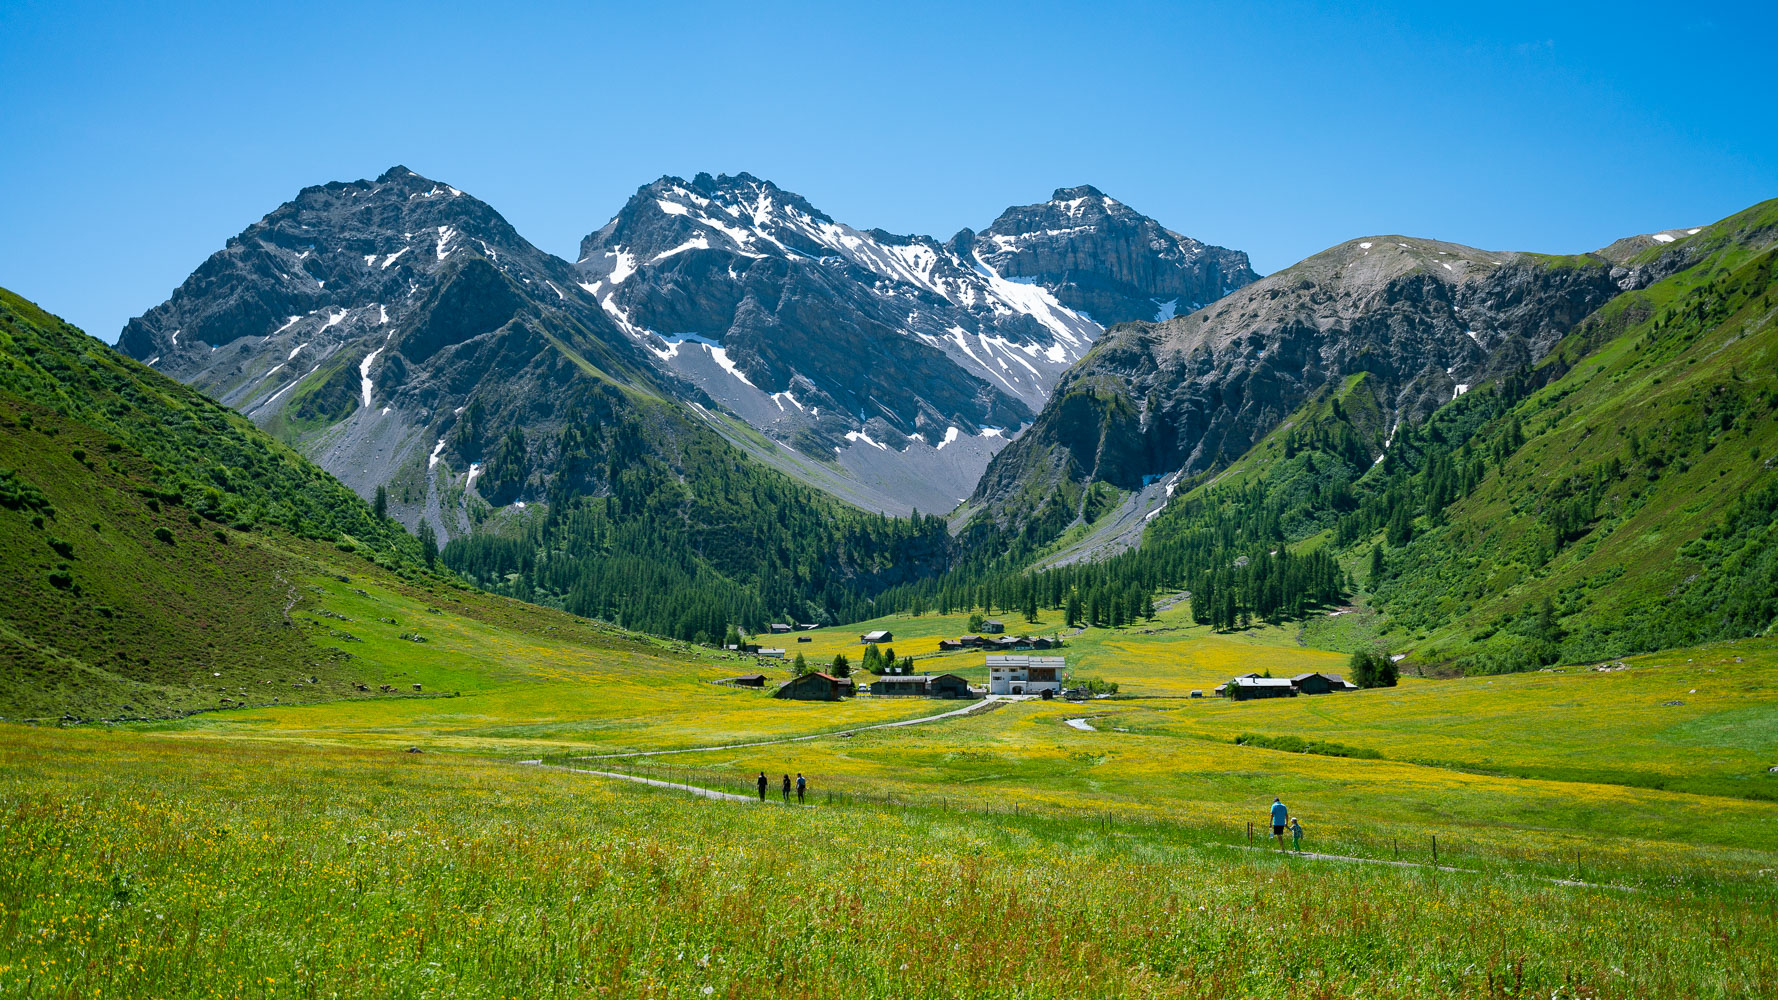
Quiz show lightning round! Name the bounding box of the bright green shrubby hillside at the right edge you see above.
[1342,203,1778,669]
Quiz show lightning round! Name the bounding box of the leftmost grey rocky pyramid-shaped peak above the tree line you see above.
[119,167,677,534]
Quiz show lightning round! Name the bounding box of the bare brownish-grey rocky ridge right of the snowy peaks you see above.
[973,237,1622,544]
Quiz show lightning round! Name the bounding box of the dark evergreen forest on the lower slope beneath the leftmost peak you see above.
[443,402,953,642]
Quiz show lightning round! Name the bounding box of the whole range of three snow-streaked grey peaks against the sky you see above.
[119,167,1253,523]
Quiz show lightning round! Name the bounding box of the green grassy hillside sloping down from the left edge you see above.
[0,284,800,719]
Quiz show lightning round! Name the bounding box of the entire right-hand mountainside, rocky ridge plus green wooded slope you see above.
[885,203,1778,671]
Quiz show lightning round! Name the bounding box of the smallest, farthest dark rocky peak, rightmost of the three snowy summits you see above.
[973,187,1259,326]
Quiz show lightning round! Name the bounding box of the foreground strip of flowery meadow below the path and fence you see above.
[0,728,1778,998]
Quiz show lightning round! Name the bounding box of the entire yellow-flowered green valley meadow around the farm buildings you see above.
[0,580,1778,998]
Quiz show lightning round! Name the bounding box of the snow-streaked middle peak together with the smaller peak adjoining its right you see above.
[578,174,1252,511]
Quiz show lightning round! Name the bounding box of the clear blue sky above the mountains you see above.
[0,0,1778,340]
